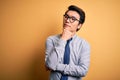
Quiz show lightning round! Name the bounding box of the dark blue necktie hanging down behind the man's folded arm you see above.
[61,38,72,80]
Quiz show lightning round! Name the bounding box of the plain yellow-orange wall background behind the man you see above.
[0,0,120,80]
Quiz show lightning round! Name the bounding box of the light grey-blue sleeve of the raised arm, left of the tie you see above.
[45,37,66,71]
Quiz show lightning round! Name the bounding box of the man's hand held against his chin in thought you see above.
[61,29,75,40]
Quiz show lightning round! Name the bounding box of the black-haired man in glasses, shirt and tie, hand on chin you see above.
[45,5,90,80]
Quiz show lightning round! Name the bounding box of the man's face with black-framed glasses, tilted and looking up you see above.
[63,10,80,32]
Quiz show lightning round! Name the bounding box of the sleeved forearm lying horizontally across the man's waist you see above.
[56,55,89,77]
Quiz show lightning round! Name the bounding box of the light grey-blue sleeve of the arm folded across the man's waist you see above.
[56,39,90,77]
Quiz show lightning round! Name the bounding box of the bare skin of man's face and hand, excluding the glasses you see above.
[61,10,82,40]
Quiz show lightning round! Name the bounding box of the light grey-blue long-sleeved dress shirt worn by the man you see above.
[45,35,90,80]
